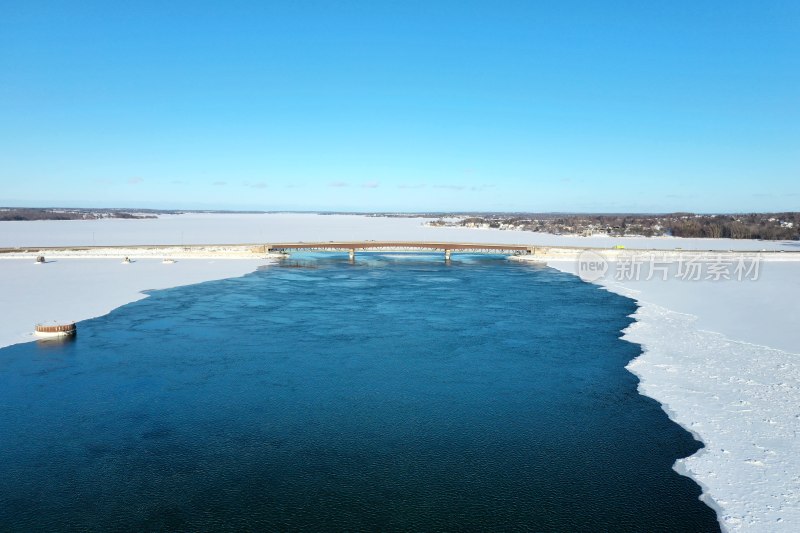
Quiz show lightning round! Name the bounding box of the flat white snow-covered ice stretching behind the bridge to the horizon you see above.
[0,213,800,251]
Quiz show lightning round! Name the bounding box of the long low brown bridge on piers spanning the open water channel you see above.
[264,241,536,261]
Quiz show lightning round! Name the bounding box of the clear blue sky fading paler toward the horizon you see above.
[0,0,800,212]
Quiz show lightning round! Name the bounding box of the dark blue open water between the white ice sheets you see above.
[0,255,718,531]
